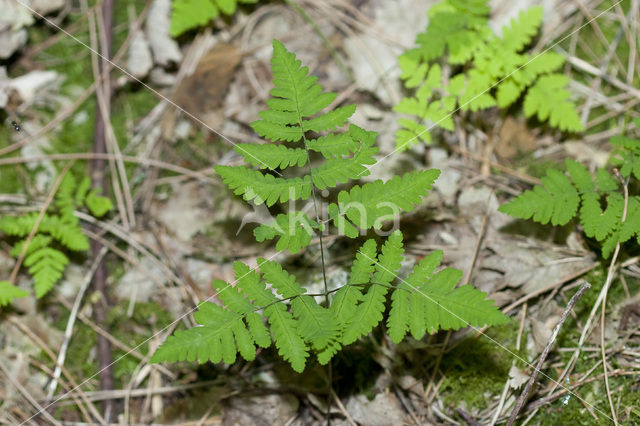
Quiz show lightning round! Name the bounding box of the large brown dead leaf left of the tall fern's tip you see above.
[175,43,242,121]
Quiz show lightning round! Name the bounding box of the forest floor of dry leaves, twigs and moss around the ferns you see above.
[0,0,640,426]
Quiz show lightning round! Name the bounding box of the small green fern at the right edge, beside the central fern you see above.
[499,129,640,258]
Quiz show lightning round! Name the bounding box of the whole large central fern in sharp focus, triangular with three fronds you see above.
[152,40,506,372]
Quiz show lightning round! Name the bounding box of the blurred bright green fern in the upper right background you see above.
[394,0,583,149]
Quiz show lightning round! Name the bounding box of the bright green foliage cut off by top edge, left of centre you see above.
[170,0,258,37]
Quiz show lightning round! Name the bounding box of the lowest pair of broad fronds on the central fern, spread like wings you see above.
[151,231,507,372]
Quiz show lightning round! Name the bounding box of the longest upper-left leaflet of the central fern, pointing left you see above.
[214,166,311,206]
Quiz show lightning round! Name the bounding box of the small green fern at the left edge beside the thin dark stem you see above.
[0,172,112,306]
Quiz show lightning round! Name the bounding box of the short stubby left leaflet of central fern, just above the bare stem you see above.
[253,212,320,254]
